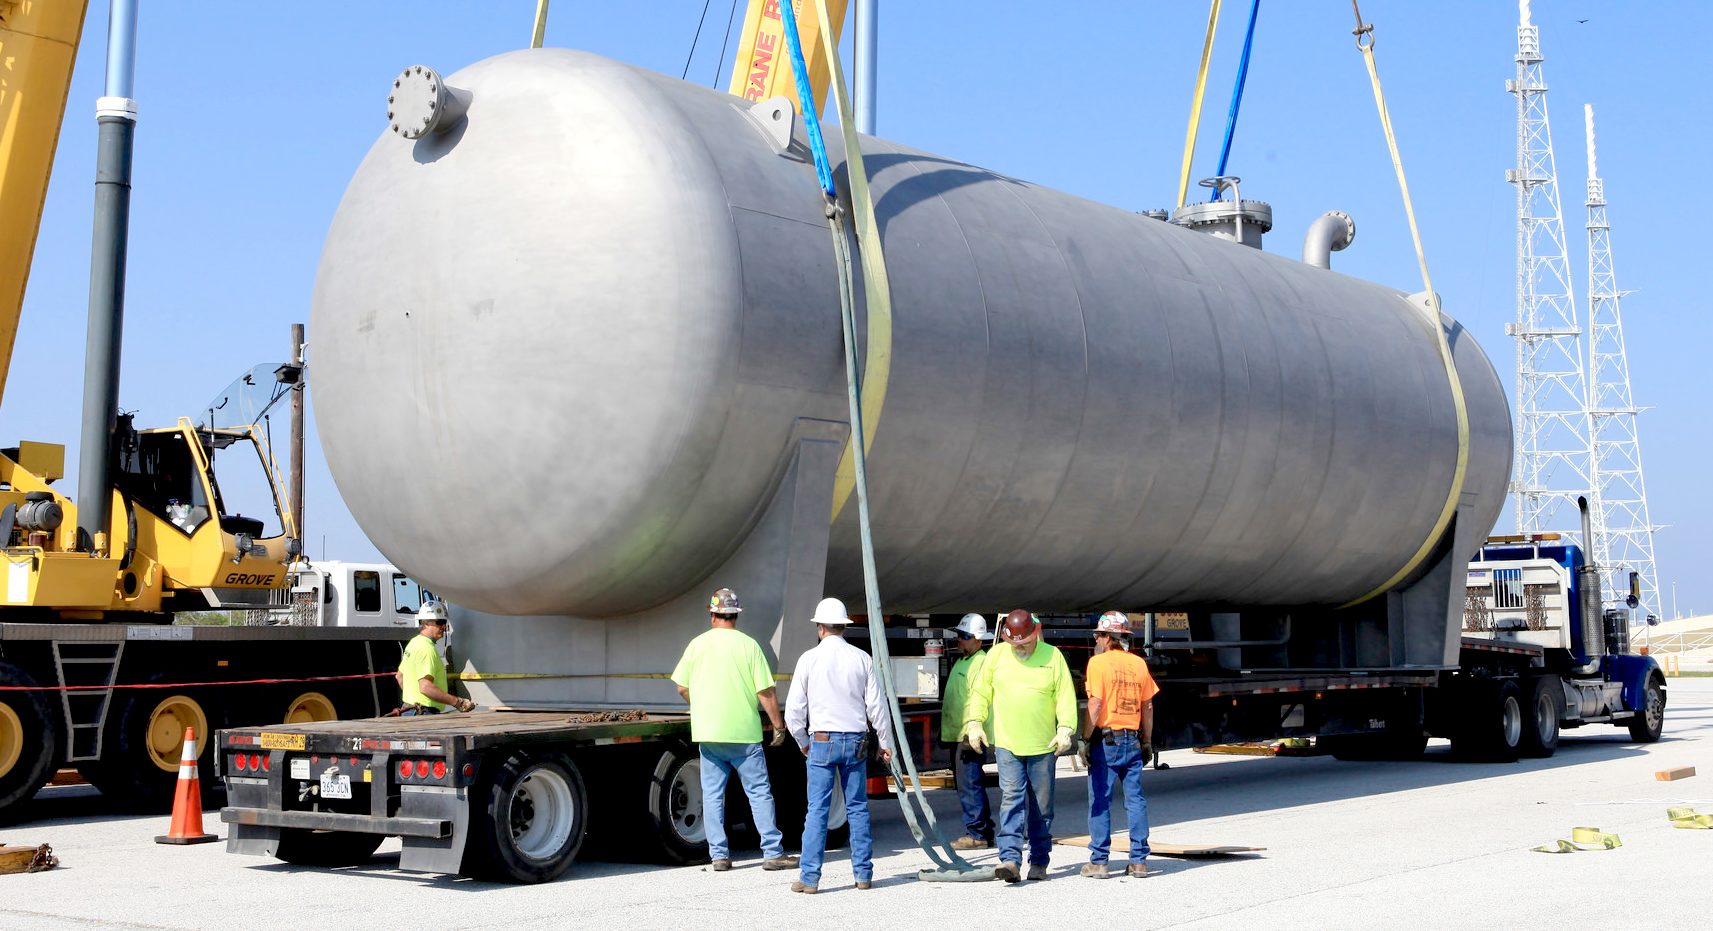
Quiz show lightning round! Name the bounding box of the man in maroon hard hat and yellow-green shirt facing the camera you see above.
[964,609,1076,883]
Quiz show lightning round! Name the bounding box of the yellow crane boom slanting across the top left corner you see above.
[0,0,89,408]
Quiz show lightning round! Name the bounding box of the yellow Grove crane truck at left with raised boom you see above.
[0,0,416,821]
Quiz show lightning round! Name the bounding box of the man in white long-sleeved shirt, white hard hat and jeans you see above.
[785,598,894,893]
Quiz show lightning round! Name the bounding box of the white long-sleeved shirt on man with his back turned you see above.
[785,634,896,751]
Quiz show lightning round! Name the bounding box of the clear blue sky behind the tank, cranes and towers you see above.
[10,0,1713,614]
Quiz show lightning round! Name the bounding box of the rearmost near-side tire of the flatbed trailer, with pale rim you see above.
[461,753,589,883]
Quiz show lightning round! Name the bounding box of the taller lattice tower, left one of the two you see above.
[1506,0,1593,540]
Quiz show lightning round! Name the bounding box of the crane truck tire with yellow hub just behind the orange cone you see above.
[77,674,224,813]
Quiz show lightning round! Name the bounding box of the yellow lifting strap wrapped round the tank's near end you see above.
[814,2,892,520]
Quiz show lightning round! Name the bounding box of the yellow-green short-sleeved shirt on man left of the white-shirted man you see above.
[671,628,773,744]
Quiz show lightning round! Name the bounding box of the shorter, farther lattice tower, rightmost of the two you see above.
[1583,105,1660,614]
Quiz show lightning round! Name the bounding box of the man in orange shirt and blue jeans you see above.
[1083,610,1160,880]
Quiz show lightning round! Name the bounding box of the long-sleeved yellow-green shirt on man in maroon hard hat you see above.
[963,643,1076,756]
